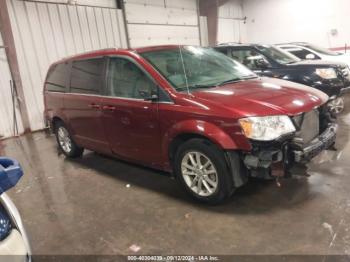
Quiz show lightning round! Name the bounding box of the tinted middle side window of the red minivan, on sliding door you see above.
[70,58,104,94]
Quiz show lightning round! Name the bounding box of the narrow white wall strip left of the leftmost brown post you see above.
[0,33,23,139]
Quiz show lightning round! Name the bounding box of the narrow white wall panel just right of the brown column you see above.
[218,0,246,43]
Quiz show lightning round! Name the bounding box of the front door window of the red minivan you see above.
[107,58,157,99]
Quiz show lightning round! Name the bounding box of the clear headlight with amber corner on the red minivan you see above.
[239,116,295,141]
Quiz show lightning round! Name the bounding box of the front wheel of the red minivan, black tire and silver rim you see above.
[174,138,234,204]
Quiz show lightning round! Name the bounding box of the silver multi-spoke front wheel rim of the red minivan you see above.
[181,151,218,196]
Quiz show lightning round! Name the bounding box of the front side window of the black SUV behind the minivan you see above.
[229,49,270,70]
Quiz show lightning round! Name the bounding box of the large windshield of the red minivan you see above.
[141,46,257,91]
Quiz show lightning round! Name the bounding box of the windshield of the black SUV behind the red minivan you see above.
[256,45,301,65]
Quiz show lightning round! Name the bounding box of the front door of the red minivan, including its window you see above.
[102,57,161,165]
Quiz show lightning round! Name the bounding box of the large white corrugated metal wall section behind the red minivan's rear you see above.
[5,0,127,130]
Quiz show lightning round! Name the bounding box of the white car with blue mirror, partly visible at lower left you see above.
[0,157,32,262]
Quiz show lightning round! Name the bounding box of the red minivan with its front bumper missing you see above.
[44,46,337,203]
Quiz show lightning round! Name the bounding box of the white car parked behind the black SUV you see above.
[277,42,350,67]
